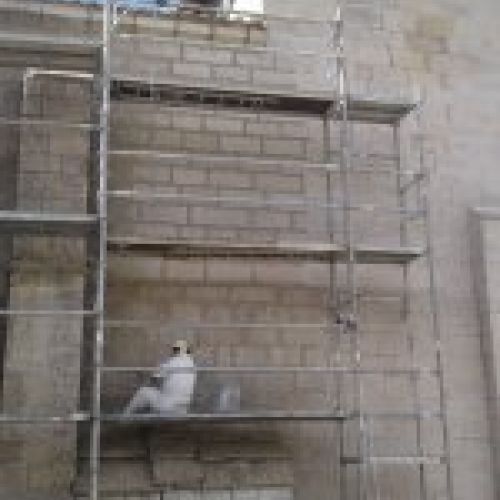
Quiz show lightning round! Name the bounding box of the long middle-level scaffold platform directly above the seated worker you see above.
[108,237,424,264]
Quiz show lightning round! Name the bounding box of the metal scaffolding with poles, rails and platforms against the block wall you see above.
[0,0,453,500]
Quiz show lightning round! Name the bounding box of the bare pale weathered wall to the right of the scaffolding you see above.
[268,1,500,499]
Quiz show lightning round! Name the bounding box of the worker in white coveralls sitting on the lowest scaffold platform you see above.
[124,340,196,415]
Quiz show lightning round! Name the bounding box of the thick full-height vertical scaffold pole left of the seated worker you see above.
[90,0,113,500]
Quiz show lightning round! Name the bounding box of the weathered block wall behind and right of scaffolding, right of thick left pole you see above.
[0,0,500,500]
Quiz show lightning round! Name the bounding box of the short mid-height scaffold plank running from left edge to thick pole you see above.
[0,210,97,236]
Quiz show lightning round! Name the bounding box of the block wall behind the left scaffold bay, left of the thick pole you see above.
[0,75,90,496]
